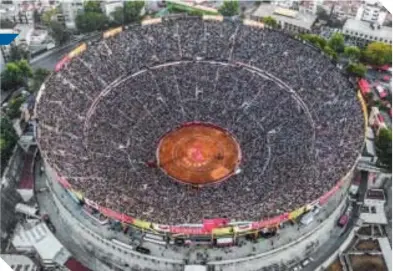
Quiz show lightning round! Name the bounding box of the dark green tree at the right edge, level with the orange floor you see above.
[375,128,392,168]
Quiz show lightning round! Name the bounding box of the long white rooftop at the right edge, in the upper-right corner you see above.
[343,19,392,40]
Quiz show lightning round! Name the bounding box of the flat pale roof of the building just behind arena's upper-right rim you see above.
[252,4,317,29]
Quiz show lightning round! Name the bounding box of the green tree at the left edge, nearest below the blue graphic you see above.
[1,60,32,90]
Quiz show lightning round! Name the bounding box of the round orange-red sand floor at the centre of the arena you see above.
[157,123,241,185]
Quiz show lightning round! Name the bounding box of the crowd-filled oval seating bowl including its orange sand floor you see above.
[36,17,364,230]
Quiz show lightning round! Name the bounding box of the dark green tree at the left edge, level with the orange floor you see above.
[0,115,18,172]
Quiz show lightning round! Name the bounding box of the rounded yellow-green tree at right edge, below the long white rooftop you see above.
[363,42,392,66]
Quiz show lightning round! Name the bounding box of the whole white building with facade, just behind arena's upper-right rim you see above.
[251,4,317,33]
